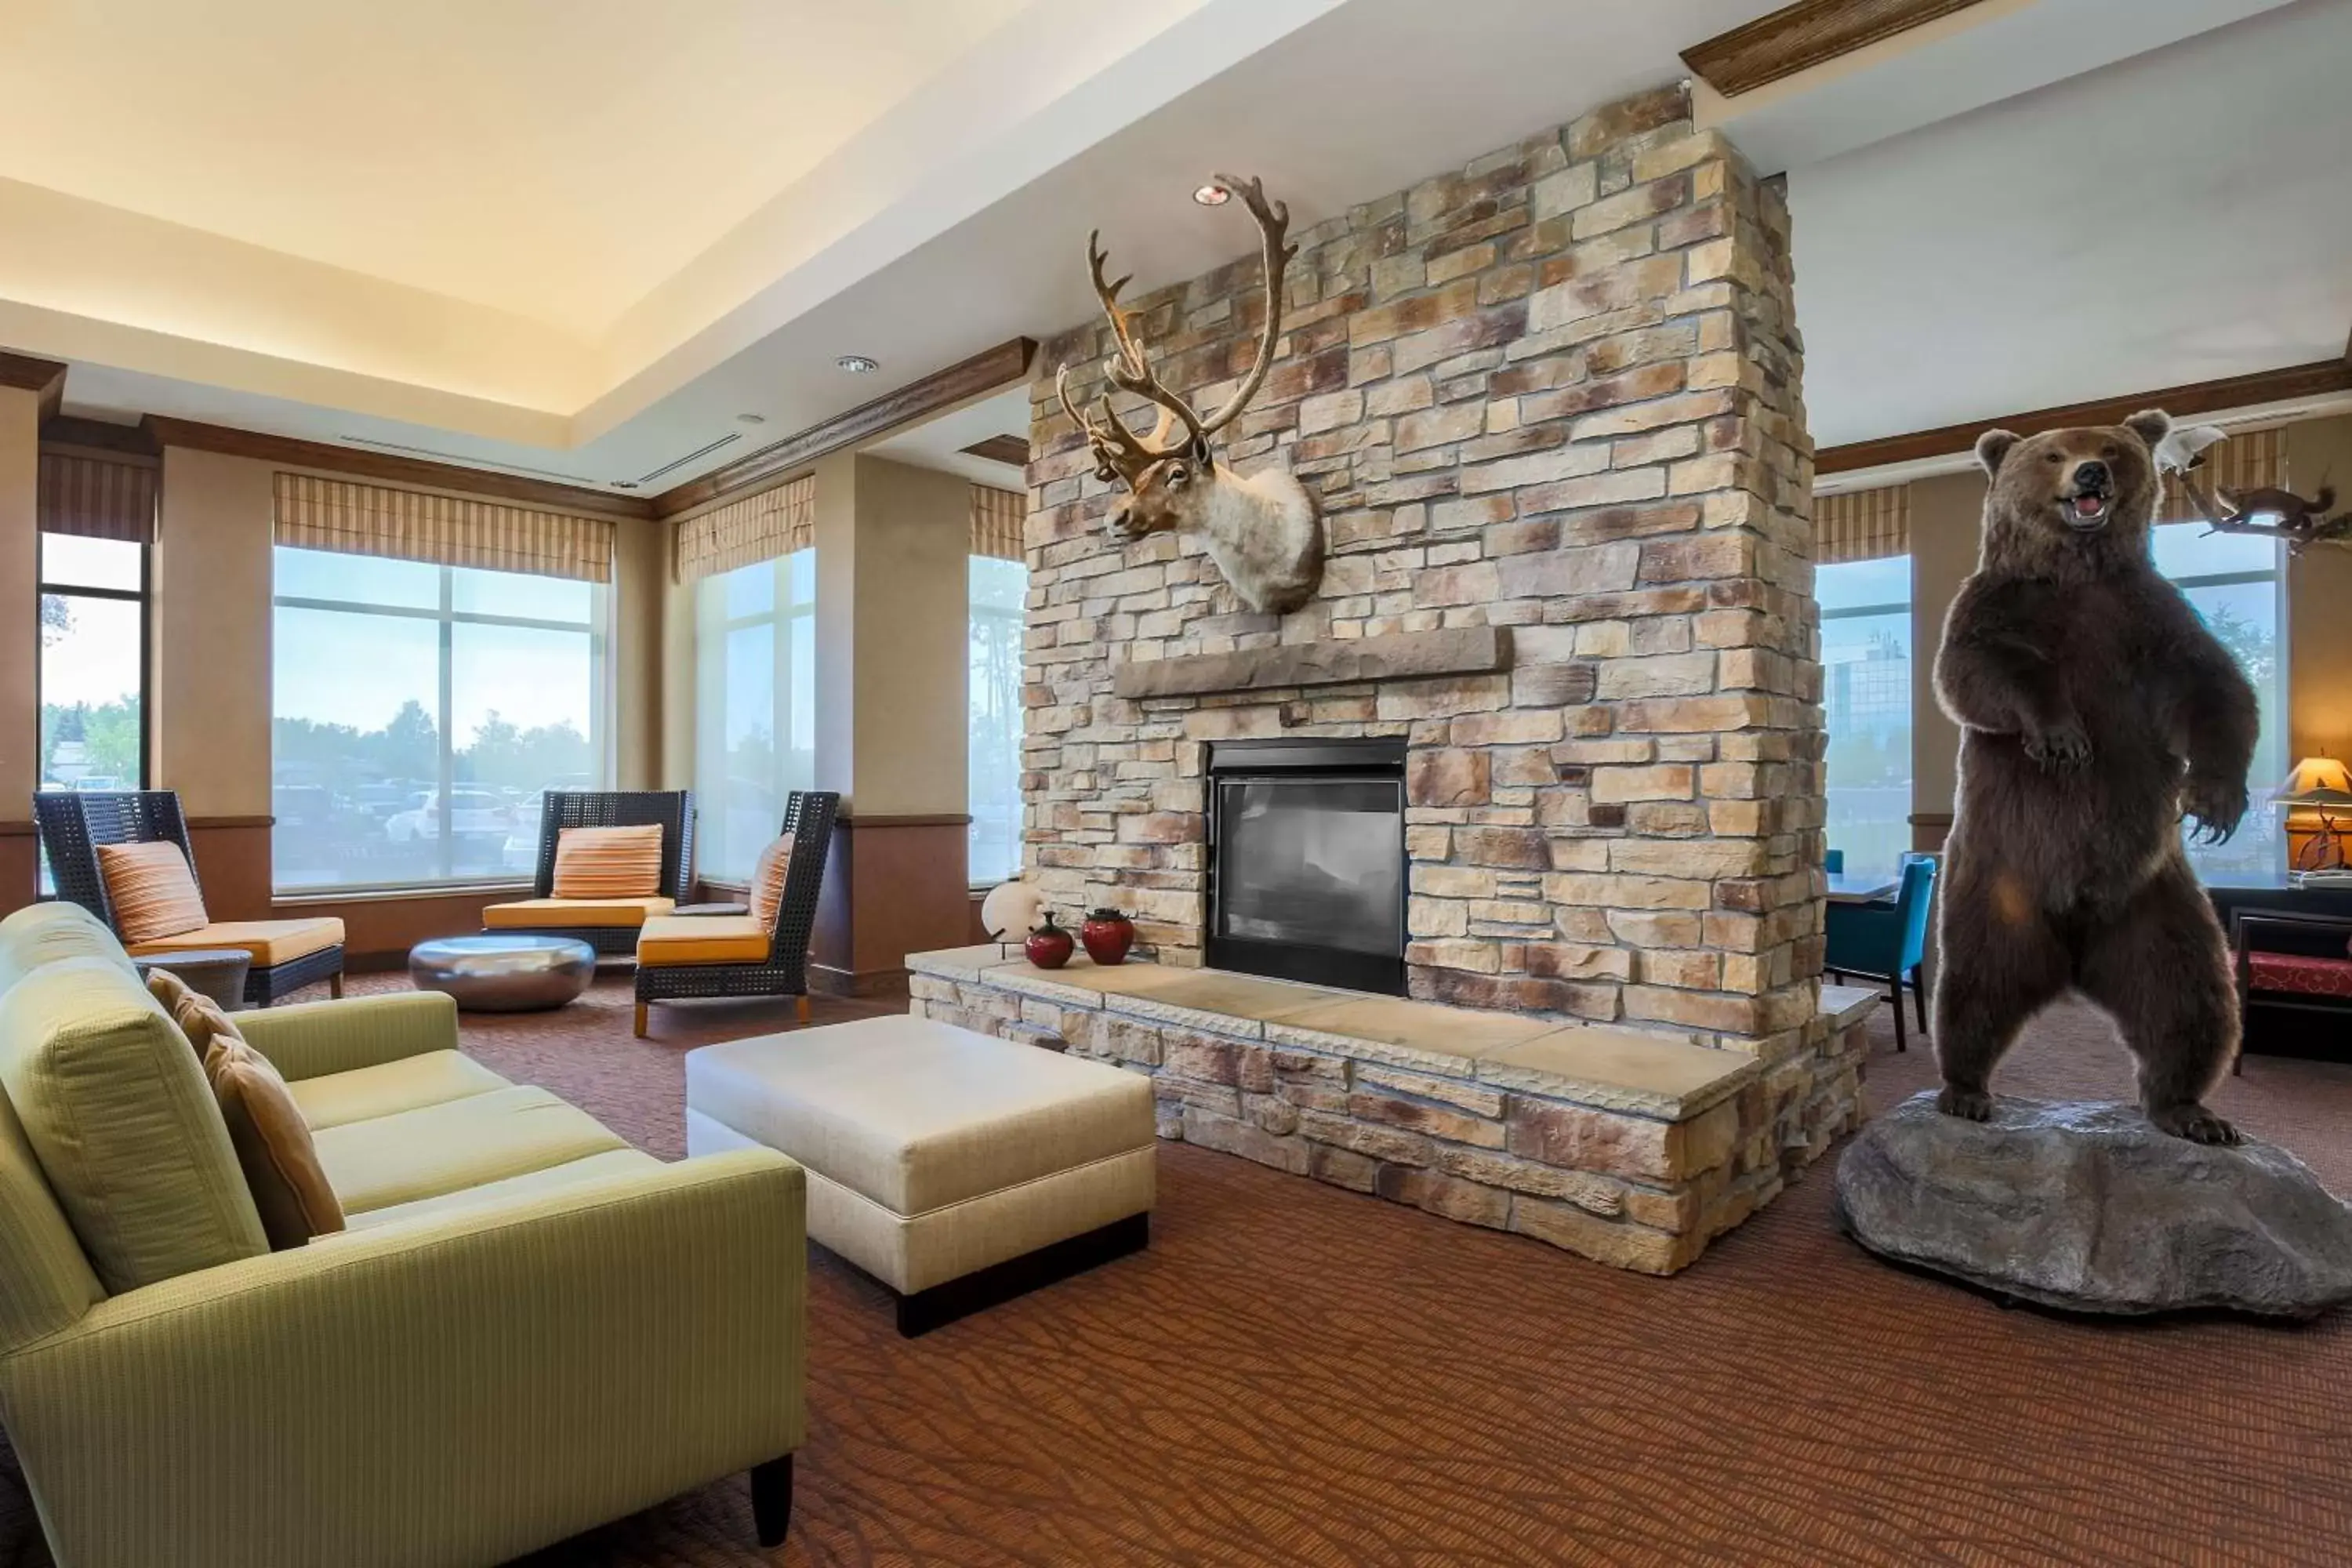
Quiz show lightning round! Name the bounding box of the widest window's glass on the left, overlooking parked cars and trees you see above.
[270,546,609,888]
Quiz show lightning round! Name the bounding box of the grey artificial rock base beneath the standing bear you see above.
[1837,1091,2352,1316]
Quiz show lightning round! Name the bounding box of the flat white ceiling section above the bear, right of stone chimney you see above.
[1788,0,2352,447]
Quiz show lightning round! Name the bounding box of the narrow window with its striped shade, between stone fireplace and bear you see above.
[1813,487,1915,874]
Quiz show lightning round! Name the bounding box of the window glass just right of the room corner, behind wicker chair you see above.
[694,550,816,881]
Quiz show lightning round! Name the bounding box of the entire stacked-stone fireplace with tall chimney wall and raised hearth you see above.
[917,89,1860,1267]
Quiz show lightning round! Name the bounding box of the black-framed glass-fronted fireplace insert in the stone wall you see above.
[1207,739,1404,996]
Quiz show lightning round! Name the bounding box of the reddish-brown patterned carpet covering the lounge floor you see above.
[0,982,2352,1568]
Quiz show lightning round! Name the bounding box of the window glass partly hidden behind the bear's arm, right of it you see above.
[2154,522,2286,881]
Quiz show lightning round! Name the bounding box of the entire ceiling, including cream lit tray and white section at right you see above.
[0,0,2352,492]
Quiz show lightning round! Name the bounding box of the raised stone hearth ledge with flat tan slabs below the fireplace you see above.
[908,945,1879,1274]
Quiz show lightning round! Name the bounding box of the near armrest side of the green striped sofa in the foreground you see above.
[0,1149,807,1568]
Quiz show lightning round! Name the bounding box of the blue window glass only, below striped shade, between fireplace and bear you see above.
[1813,555,1912,872]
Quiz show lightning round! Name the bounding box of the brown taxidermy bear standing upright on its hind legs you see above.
[1936,412,2256,1142]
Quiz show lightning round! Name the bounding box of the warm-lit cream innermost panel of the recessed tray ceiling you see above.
[0,0,1028,336]
